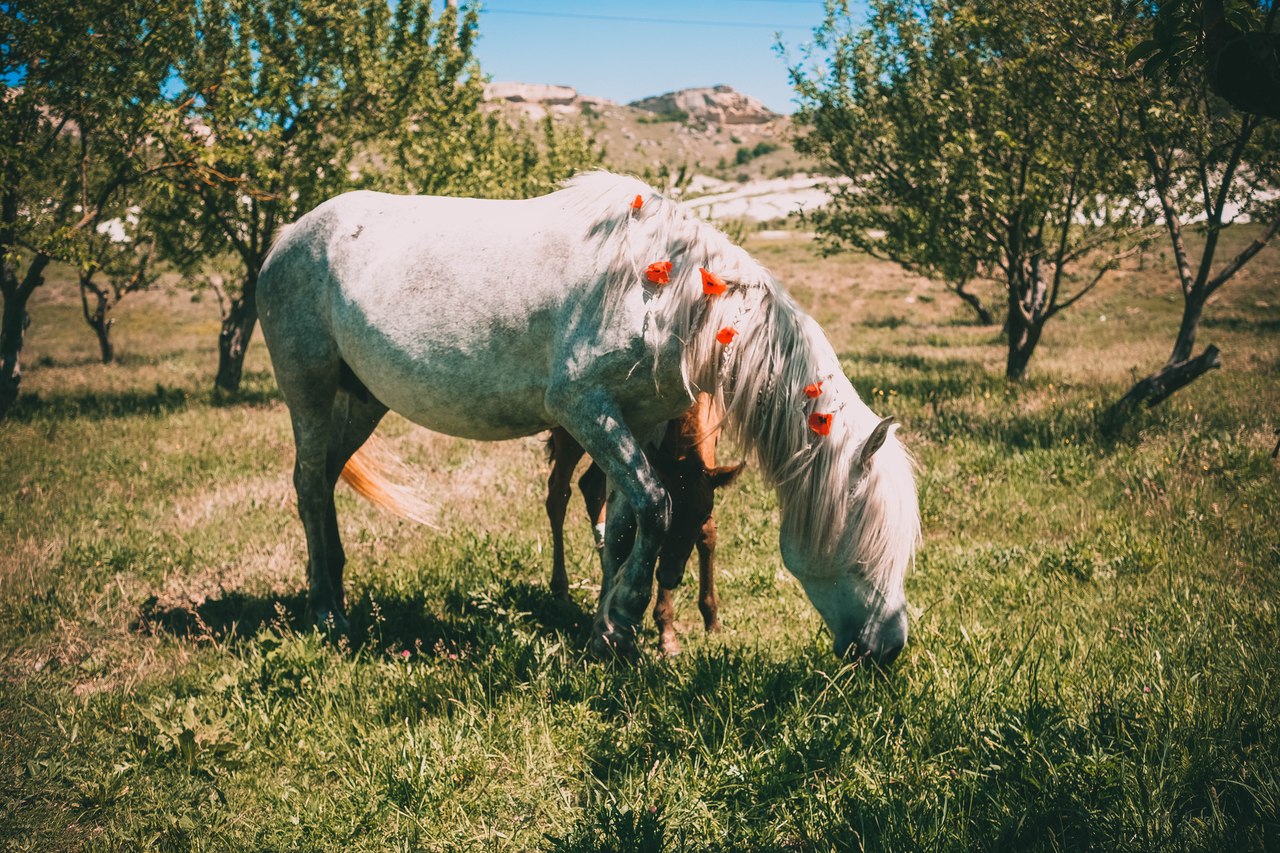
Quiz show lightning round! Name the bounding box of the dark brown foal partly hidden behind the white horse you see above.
[547,394,746,654]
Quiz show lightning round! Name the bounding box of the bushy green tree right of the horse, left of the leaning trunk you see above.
[791,0,1149,379]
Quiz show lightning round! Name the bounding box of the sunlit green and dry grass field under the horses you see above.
[0,234,1280,850]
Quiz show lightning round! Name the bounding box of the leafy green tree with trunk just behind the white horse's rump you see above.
[164,0,475,391]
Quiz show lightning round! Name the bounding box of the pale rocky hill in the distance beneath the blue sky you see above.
[485,83,827,222]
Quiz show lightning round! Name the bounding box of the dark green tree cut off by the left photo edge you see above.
[0,0,189,418]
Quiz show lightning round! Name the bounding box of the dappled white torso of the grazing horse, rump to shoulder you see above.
[259,185,686,438]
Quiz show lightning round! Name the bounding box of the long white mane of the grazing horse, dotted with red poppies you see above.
[558,172,919,589]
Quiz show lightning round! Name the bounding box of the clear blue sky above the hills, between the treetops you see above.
[476,0,849,113]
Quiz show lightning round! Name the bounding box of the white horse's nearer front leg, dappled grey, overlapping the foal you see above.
[548,389,671,658]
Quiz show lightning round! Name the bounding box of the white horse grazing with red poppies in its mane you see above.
[257,172,919,662]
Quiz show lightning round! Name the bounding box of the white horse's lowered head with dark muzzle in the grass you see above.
[781,418,920,665]
